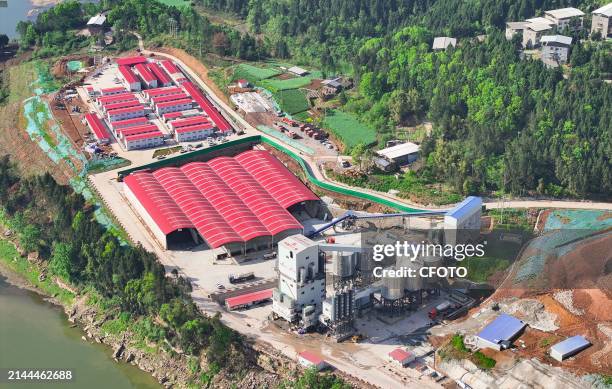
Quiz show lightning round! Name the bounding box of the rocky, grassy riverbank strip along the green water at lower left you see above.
[0,235,340,388]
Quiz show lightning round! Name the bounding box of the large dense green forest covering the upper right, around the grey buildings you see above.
[197,0,612,196]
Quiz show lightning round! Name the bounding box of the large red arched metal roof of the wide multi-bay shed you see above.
[124,151,318,248]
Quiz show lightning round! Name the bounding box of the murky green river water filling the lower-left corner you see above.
[0,275,160,389]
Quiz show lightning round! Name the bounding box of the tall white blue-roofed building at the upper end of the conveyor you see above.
[444,196,482,245]
